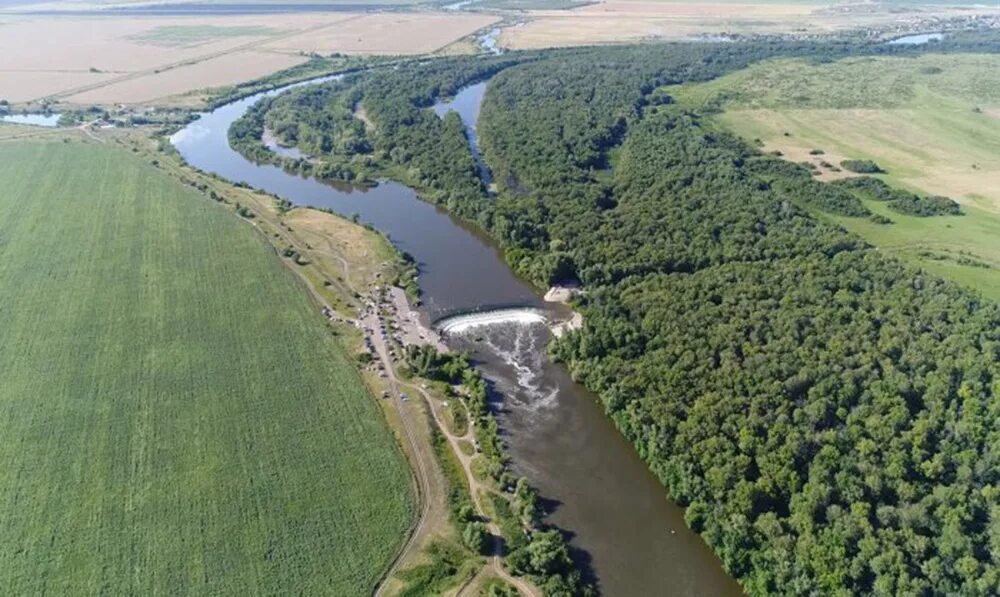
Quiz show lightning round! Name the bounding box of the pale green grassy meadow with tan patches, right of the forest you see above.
[670,54,1000,300]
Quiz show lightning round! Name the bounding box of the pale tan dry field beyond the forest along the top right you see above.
[500,0,1000,49]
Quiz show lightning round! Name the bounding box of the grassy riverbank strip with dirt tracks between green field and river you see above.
[145,122,541,597]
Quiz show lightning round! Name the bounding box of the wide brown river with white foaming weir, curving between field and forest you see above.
[172,72,741,597]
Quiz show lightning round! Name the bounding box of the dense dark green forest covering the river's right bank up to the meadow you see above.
[236,34,1000,595]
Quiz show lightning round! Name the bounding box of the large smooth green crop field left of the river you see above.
[0,141,414,595]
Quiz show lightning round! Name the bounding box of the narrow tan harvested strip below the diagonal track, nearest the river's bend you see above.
[66,50,306,104]
